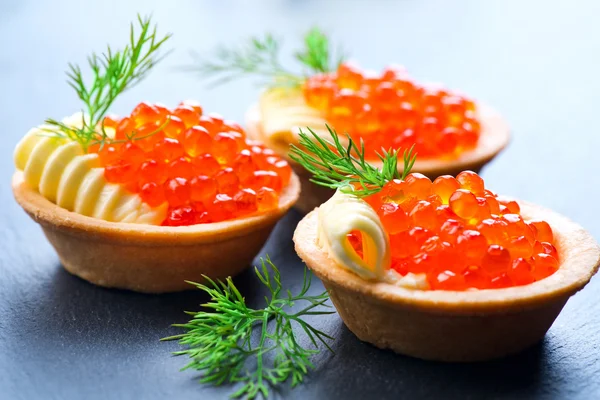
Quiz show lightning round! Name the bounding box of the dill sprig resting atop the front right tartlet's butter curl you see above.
[290,125,416,197]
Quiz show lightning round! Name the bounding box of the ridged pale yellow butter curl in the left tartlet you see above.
[14,113,168,225]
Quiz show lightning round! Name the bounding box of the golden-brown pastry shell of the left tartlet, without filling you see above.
[12,172,300,293]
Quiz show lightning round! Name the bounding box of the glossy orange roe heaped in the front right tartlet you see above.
[349,171,559,290]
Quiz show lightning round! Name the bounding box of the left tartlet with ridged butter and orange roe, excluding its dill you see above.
[12,106,300,293]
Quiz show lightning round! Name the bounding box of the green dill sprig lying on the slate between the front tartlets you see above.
[162,256,333,399]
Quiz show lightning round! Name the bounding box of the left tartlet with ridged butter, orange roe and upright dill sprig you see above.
[12,18,299,292]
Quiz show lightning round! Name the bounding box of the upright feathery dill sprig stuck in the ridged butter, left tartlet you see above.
[45,14,171,149]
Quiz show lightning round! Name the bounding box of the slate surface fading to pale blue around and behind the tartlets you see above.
[0,0,600,399]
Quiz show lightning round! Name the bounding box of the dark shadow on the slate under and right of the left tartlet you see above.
[9,212,310,350]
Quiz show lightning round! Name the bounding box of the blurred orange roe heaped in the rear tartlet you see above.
[304,63,481,159]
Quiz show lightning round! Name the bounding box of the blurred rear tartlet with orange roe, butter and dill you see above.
[190,29,509,211]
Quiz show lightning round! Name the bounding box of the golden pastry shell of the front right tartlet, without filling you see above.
[294,202,600,361]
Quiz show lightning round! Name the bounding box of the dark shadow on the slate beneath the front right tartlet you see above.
[300,322,569,399]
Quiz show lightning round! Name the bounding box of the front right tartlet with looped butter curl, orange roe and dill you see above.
[292,129,600,361]
